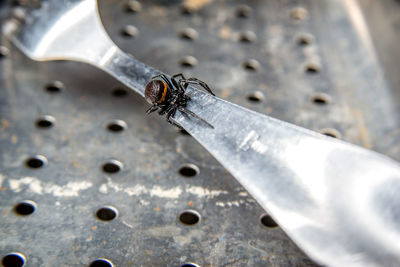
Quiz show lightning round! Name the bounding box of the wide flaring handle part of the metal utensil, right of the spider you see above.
[176,90,400,266]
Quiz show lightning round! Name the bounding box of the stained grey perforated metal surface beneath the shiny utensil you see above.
[0,0,400,266]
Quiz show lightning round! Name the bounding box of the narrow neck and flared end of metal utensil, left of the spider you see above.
[10,0,158,96]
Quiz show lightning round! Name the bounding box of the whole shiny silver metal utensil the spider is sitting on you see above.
[8,0,400,266]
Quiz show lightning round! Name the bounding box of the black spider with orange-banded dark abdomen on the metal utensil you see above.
[144,73,214,128]
